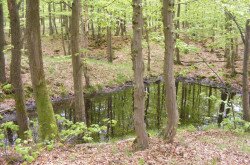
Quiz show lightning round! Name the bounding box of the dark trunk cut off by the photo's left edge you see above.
[0,3,6,83]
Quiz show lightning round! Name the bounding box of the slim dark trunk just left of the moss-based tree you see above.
[8,0,29,139]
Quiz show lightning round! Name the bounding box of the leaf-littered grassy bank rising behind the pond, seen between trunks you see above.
[0,36,246,111]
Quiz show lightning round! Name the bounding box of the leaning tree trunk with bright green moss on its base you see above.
[26,0,58,140]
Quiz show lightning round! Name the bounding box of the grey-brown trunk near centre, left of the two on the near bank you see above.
[131,0,148,150]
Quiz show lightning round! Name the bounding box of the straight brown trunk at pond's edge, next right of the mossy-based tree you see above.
[71,0,86,123]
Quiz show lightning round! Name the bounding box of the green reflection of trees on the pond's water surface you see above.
[57,82,241,137]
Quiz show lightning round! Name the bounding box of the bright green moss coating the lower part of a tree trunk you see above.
[34,82,58,140]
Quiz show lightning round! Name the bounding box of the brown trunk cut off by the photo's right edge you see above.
[242,20,250,121]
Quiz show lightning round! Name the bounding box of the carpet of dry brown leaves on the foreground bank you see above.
[33,131,250,165]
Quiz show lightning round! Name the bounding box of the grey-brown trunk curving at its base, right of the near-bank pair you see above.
[162,0,179,142]
